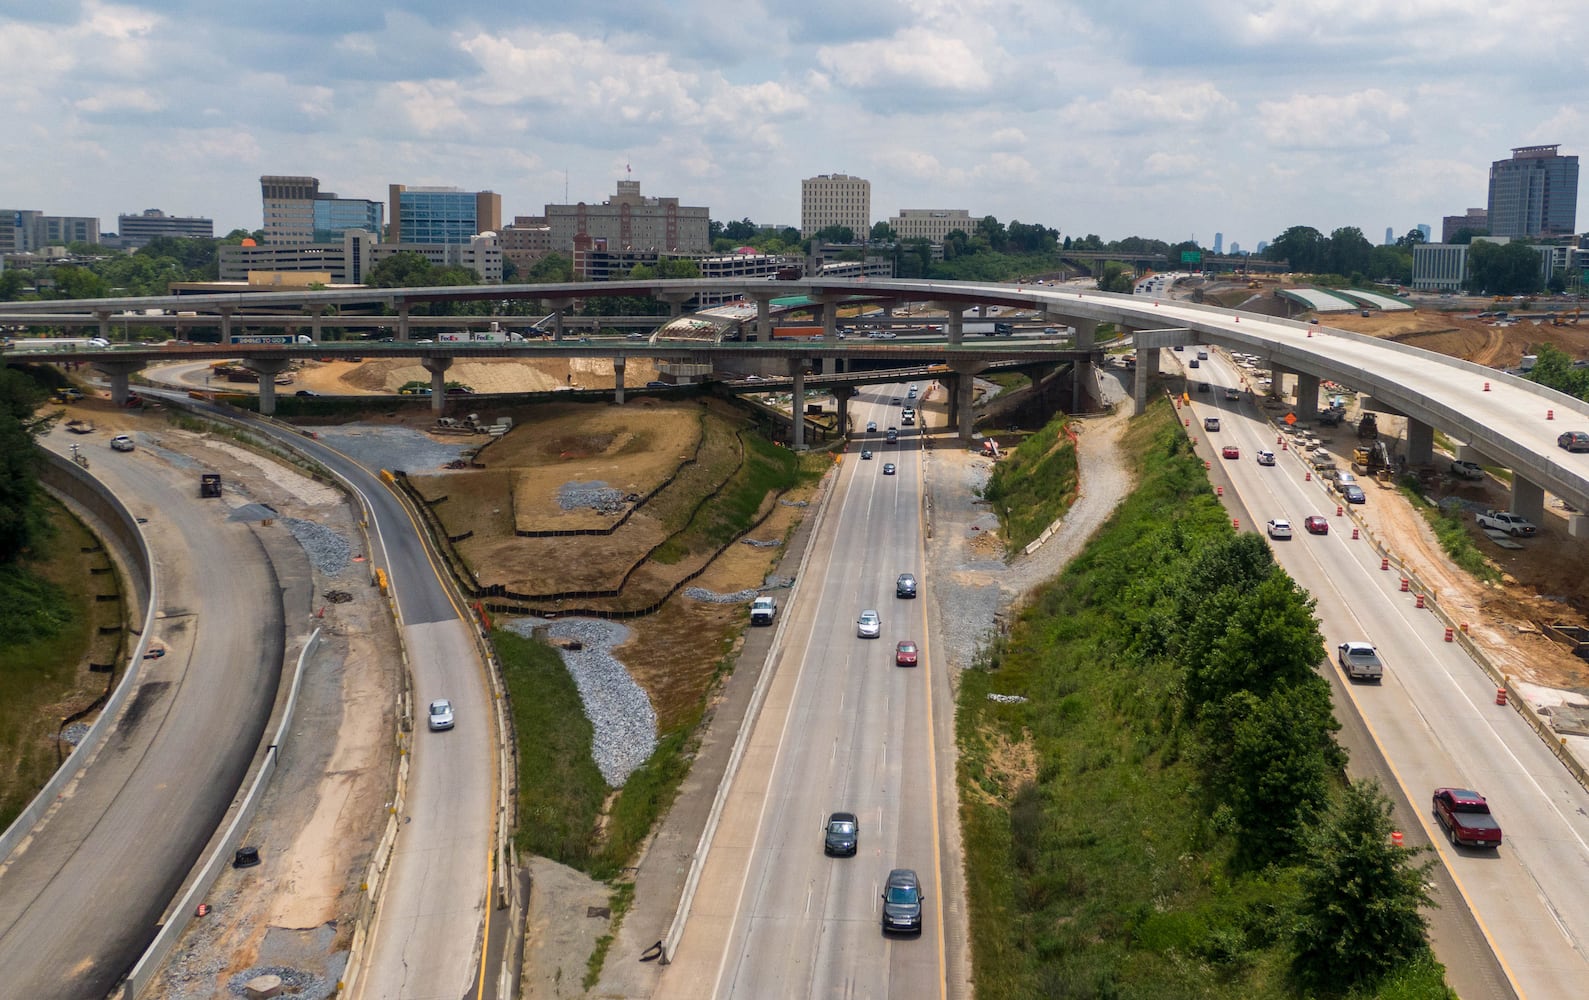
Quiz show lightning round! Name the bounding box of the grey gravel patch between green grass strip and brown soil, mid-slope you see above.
[507,618,656,789]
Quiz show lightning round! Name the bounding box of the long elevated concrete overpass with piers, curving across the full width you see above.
[0,278,1589,521]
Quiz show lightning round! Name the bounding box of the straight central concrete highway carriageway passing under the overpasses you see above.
[658,378,949,998]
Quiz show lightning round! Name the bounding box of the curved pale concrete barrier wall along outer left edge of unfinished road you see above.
[0,450,159,862]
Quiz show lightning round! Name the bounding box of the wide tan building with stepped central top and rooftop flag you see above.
[502,181,712,260]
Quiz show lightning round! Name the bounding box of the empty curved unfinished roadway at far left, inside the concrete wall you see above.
[0,431,286,1000]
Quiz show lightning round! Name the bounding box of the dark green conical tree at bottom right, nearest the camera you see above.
[1292,781,1435,992]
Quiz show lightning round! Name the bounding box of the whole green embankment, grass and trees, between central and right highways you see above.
[957,405,1449,1000]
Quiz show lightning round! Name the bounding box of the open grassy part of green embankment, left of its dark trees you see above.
[957,407,1444,1000]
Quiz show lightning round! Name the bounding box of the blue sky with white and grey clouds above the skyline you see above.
[0,0,1589,250]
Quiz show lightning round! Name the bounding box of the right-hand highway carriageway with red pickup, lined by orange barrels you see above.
[1190,354,1589,997]
